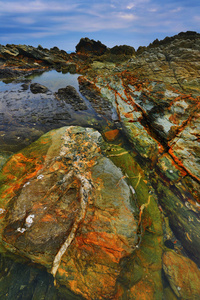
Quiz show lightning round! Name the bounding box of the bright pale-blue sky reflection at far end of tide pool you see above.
[28,70,80,92]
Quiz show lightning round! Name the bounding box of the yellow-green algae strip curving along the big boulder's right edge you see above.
[107,145,163,299]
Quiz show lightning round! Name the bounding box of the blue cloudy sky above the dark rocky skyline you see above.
[0,0,200,51]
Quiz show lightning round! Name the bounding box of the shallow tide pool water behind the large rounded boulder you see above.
[0,70,112,152]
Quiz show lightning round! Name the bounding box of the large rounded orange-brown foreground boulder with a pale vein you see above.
[0,127,138,299]
